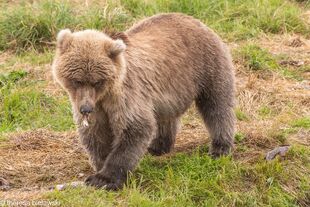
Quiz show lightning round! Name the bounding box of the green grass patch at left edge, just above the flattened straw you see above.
[0,88,73,132]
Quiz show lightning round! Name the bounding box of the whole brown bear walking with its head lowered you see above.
[52,13,235,190]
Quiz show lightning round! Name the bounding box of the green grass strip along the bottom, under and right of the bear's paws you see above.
[46,147,310,207]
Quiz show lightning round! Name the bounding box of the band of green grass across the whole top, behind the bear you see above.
[0,0,310,52]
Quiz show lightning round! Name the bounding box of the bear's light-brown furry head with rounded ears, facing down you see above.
[52,29,126,125]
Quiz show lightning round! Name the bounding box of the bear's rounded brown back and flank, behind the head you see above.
[121,13,229,115]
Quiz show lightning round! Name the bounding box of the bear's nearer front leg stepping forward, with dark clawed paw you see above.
[85,116,156,190]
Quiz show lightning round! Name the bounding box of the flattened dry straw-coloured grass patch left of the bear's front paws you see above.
[0,130,91,196]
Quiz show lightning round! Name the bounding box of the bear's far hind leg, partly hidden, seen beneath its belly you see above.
[148,118,180,156]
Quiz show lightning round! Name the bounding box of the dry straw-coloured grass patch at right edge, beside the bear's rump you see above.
[237,68,310,147]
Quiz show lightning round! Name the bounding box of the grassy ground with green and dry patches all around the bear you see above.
[0,0,310,206]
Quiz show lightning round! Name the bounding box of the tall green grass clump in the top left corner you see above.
[0,1,74,52]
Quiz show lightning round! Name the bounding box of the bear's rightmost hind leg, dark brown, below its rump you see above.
[196,87,235,157]
